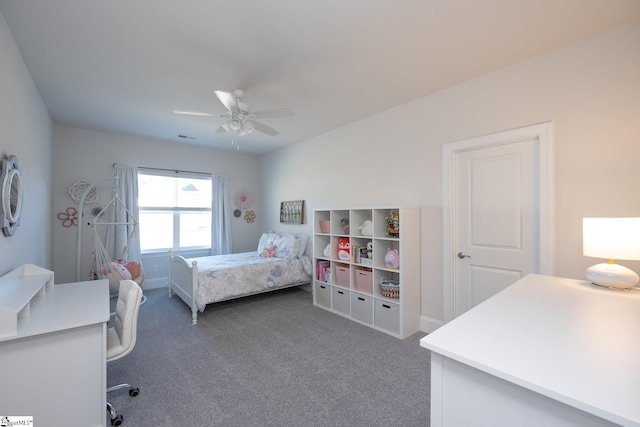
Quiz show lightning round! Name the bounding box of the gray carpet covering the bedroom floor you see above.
[105,288,430,427]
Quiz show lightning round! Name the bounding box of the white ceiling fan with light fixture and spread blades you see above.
[173,89,295,147]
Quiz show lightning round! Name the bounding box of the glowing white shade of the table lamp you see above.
[582,218,640,260]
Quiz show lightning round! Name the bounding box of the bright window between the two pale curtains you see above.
[138,169,211,253]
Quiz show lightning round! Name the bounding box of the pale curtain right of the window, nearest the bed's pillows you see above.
[211,175,231,255]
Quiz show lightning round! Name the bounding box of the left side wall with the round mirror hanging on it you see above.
[0,10,52,280]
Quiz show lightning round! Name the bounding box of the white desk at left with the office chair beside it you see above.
[0,268,109,427]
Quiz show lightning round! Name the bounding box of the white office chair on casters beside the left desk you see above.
[107,280,142,426]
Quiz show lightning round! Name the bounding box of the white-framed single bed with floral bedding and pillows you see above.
[168,233,312,325]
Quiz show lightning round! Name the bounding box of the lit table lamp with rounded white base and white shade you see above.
[582,218,640,289]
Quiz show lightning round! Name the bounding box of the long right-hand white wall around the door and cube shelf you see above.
[261,22,640,328]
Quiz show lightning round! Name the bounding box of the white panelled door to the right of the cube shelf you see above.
[443,124,552,320]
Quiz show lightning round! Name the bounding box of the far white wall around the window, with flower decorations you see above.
[52,125,263,287]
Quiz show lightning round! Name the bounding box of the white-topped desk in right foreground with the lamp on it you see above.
[421,274,640,427]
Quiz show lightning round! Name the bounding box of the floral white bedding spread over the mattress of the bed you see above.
[187,251,312,312]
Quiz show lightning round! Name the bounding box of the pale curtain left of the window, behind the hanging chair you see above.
[105,164,140,262]
